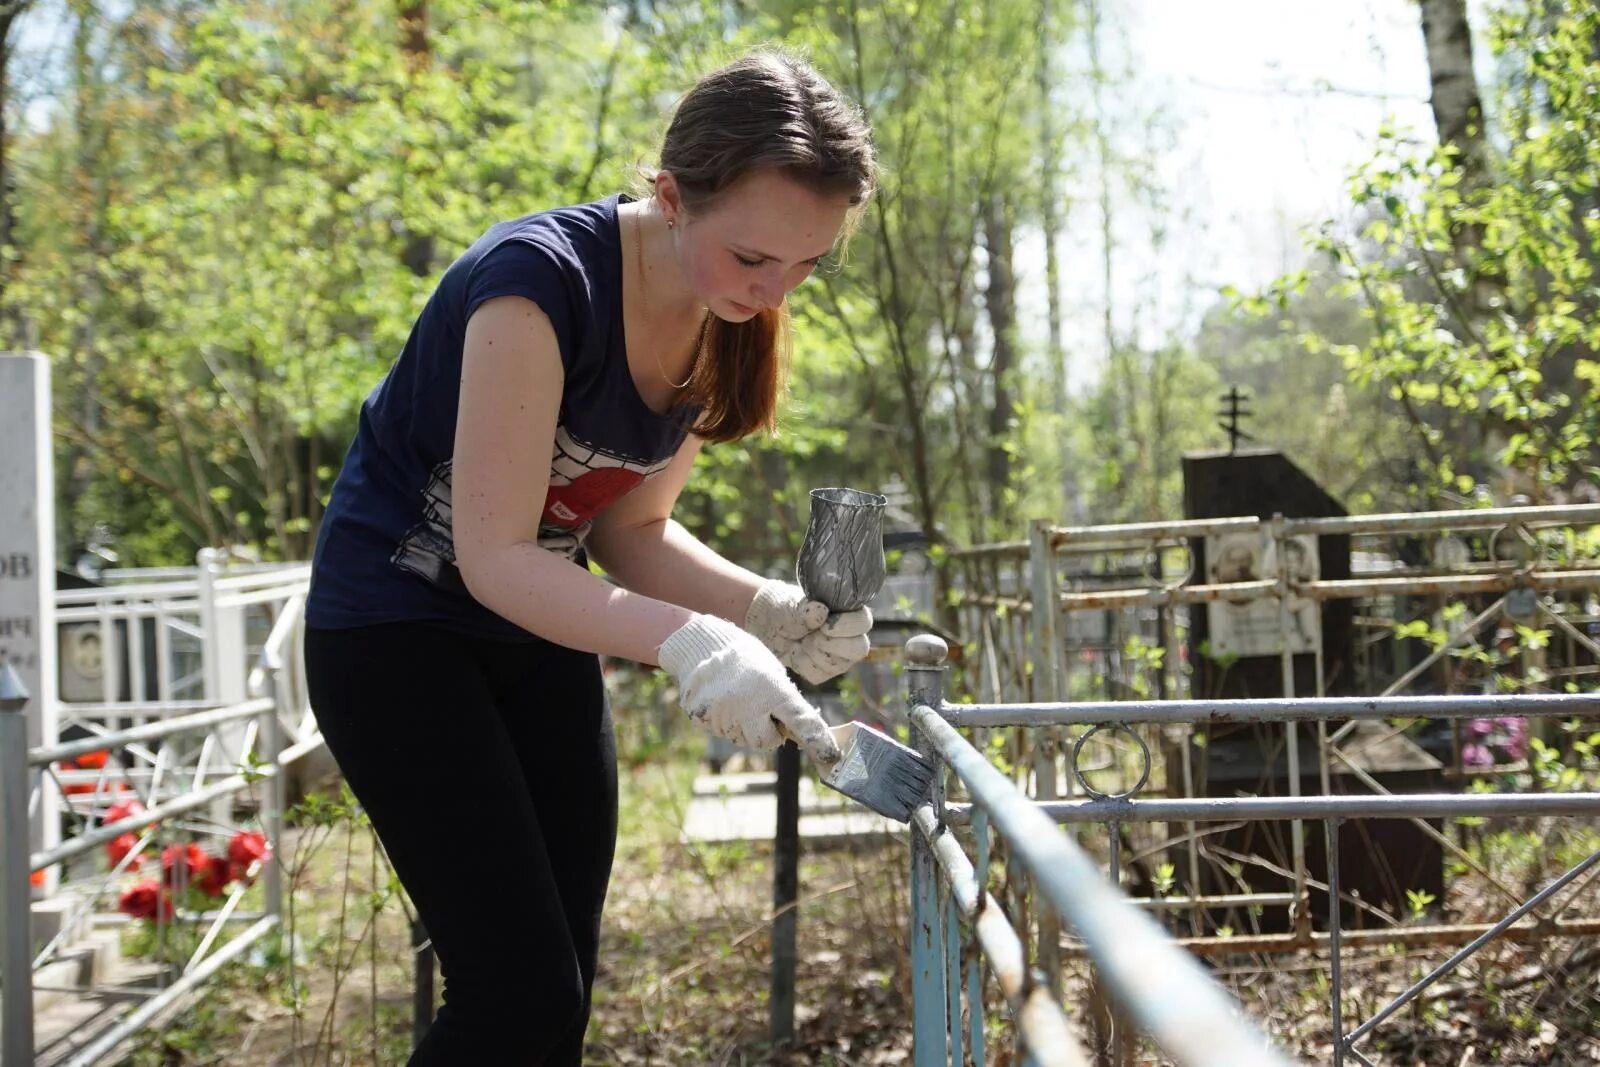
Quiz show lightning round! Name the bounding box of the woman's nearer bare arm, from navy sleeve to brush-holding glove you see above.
[451,296,693,664]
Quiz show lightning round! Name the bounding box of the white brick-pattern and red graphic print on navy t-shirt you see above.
[390,426,672,590]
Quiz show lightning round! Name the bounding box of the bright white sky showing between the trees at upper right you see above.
[1018,0,1486,387]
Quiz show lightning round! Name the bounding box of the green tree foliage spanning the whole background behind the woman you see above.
[21,0,1600,591]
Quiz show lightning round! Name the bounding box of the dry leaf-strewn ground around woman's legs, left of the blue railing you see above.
[125,742,910,1067]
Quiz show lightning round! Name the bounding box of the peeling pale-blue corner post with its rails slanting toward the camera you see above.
[906,635,1290,1067]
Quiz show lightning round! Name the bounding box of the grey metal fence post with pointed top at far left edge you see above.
[0,657,34,1067]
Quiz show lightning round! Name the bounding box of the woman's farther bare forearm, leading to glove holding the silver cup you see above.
[587,435,765,625]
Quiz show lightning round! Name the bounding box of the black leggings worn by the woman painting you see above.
[306,622,616,1067]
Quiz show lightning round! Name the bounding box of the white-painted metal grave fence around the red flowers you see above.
[0,550,322,1067]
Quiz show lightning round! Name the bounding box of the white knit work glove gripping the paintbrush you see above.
[658,614,838,763]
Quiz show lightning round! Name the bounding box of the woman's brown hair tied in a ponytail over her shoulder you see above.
[661,48,877,442]
